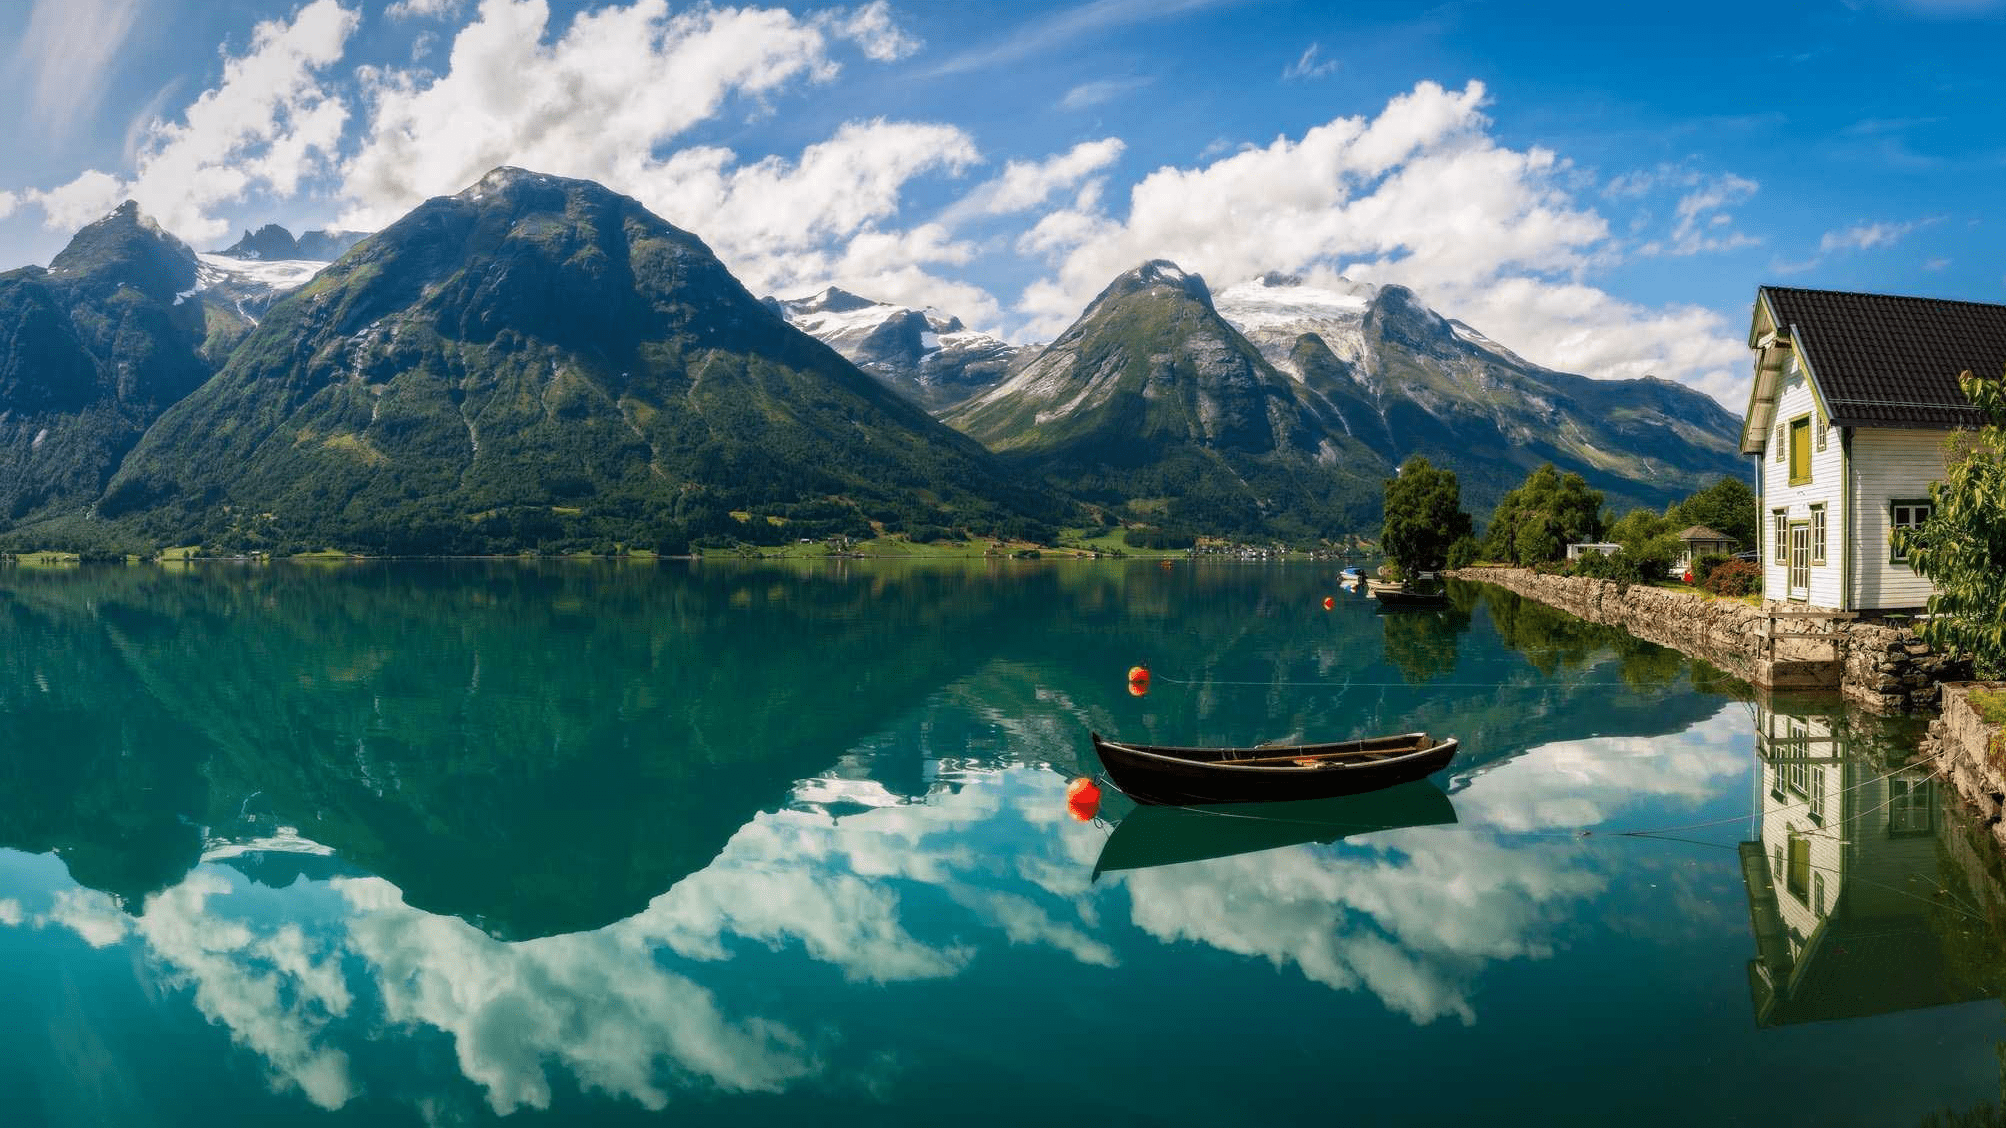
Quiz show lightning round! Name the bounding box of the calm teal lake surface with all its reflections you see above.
[0,560,2006,1128]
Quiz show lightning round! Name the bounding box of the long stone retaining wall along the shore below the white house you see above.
[1452,568,1970,713]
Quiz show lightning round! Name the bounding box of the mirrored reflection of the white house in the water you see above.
[1741,704,1982,1026]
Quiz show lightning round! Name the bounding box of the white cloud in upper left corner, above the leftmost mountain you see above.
[26,0,357,243]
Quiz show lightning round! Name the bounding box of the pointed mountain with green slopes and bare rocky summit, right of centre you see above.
[947,261,1392,538]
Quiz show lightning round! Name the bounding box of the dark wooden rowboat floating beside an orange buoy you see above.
[1091,733,1456,807]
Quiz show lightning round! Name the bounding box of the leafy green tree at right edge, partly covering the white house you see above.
[1894,371,2006,678]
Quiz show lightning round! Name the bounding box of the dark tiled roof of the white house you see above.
[1761,285,2006,428]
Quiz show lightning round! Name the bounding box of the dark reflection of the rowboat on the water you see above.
[1093,781,1456,877]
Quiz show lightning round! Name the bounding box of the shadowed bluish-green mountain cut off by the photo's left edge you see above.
[0,203,247,532]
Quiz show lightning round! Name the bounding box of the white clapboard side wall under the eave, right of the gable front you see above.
[1854,428,1950,610]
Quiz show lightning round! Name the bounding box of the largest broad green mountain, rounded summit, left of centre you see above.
[98,169,1065,552]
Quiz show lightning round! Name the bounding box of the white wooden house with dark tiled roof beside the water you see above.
[1741,285,2006,612]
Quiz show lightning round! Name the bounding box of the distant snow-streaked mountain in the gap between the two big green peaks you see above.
[766,287,1035,413]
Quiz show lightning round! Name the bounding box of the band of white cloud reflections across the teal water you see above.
[0,707,1747,1114]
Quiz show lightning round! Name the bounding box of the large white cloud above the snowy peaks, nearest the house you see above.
[1017,82,1753,405]
